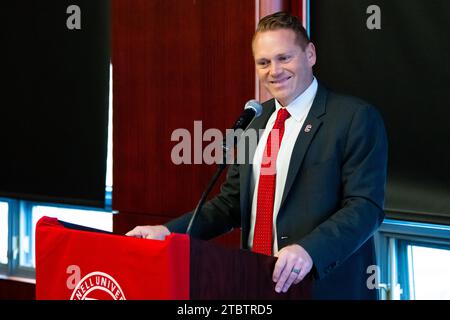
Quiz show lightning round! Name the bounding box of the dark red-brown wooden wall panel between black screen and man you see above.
[112,0,255,241]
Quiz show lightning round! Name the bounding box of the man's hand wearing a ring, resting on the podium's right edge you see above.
[272,244,313,292]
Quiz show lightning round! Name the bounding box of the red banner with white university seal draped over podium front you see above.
[36,217,190,300]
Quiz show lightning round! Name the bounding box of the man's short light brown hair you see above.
[252,11,311,50]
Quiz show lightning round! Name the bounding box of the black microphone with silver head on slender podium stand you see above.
[186,100,262,235]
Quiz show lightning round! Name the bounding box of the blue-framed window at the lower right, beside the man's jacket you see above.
[375,219,450,300]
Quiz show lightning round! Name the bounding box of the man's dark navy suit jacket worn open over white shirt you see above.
[166,83,387,299]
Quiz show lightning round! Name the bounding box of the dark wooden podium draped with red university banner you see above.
[36,217,312,300]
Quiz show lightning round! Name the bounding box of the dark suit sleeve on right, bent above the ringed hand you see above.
[298,106,387,278]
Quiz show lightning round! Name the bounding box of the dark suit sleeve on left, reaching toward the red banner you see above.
[165,165,241,240]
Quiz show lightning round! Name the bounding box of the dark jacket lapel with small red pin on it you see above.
[280,84,328,208]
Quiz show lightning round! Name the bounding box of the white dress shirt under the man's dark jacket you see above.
[248,78,318,254]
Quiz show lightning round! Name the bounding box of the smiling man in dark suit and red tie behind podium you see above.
[128,12,387,299]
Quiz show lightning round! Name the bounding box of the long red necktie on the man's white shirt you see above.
[253,108,290,256]
